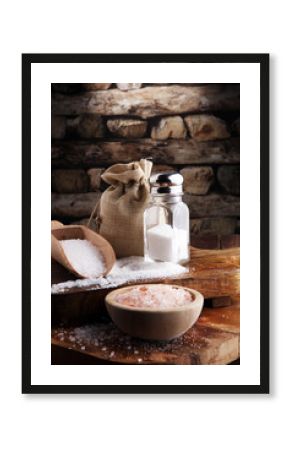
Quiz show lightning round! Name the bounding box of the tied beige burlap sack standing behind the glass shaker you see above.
[91,159,152,258]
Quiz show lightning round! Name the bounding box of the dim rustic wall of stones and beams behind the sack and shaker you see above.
[51,83,240,242]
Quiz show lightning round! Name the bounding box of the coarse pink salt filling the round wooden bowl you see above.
[115,284,192,308]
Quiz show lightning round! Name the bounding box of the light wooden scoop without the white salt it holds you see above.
[51,221,116,278]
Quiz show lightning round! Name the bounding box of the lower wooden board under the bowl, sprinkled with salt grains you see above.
[52,303,240,365]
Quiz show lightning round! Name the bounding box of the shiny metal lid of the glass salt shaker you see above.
[150,172,183,195]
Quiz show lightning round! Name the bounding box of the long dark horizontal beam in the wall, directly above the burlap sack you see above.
[51,138,240,169]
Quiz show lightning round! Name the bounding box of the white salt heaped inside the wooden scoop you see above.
[59,239,105,278]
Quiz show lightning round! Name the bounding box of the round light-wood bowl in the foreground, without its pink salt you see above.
[105,284,204,341]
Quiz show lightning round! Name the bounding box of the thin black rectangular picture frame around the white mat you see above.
[22,54,270,394]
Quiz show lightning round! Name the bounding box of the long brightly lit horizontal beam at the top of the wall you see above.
[51,84,240,118]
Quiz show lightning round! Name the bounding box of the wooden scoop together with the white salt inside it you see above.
[51,225,116,278]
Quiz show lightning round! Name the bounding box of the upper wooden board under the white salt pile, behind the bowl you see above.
[51,247,240,326]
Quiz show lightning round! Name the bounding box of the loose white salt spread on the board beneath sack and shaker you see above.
[51,256,188,294]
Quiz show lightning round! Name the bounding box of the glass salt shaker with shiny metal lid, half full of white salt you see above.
[144,172,189,264]
